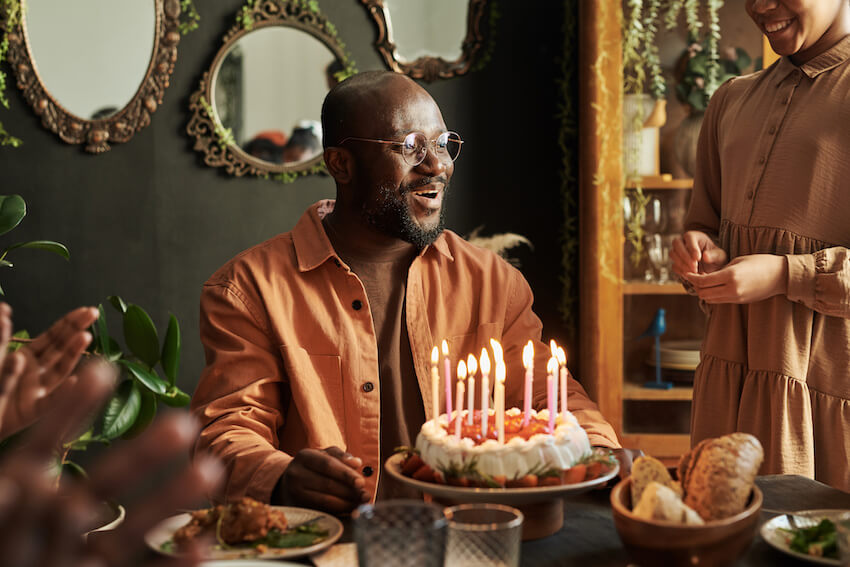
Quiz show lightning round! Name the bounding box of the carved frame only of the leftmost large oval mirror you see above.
[2,0,180,154]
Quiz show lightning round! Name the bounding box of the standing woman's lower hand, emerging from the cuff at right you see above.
[687,254,788,303]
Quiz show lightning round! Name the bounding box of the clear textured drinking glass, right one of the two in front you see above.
[445,504,523,567]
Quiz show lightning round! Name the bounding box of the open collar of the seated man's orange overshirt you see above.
[292,199,454,272]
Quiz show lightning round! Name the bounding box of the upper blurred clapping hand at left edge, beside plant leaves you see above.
[0,303,98,439]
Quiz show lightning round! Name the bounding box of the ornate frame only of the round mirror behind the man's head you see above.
[186,0,356,182]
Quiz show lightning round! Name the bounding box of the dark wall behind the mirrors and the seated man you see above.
[0,0,564,398]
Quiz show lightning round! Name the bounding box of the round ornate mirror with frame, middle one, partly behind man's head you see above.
[187,0,355,181]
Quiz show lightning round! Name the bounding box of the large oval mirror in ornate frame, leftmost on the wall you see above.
[4,0,180,153]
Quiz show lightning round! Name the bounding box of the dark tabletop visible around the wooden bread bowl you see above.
[521,475,850,567]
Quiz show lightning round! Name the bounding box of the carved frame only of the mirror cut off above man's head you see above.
[360,0,488,83]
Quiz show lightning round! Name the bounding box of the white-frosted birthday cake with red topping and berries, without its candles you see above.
[394,408,616,488]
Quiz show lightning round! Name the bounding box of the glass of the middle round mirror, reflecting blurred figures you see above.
[213,26,342,164]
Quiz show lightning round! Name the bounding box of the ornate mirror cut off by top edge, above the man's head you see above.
[360,0,488,82]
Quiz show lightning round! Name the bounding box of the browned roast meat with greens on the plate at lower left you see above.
[163,497,328,553]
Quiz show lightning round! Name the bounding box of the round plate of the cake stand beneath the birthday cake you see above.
[384,453,620,506]
